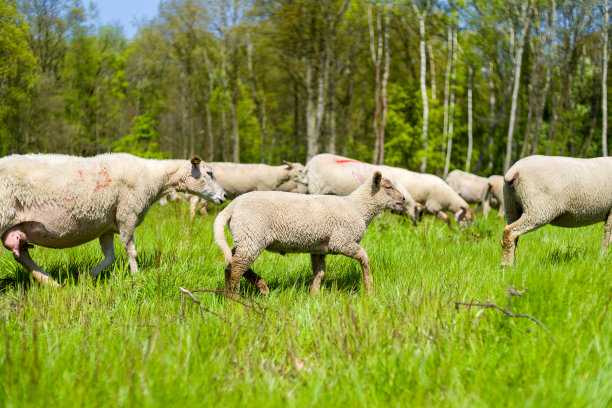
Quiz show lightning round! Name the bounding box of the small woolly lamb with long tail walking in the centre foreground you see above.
[214,171,405,296]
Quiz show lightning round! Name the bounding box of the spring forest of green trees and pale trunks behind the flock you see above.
[0,0,609,175]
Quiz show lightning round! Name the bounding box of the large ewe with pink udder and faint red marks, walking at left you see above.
[0,153,225,286]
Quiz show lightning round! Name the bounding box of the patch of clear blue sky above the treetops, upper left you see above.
[92,0,159,38]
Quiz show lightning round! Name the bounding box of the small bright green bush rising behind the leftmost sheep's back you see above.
[113,113,168,159]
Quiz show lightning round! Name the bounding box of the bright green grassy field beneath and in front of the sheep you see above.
[0,203,612,407]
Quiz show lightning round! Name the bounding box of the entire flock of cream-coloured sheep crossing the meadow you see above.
[0,153,612,295]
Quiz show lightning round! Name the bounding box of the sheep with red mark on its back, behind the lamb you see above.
[306,153,421,226]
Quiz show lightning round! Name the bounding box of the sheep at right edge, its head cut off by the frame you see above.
[502,156,612,266]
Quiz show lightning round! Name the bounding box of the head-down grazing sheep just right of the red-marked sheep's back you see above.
[389,167,474,231]
